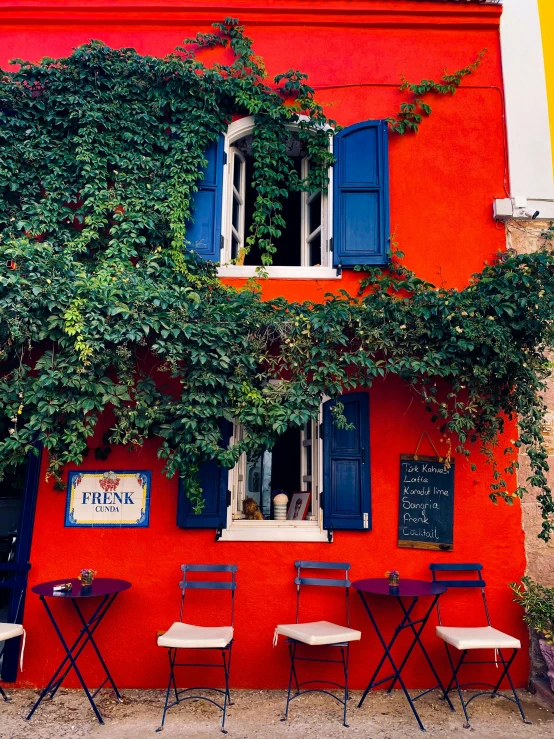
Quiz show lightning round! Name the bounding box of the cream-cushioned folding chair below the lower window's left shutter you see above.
[157,565,238,734]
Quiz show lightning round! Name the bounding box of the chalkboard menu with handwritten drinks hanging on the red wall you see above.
[398,454,454,551]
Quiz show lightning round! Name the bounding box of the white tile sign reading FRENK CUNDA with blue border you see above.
[65,470,152,528]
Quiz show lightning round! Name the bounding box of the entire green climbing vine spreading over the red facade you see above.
[0,19,554,539]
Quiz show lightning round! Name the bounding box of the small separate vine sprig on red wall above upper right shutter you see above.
[387,49,487,135]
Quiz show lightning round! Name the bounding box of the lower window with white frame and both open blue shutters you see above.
[177,392,371,542]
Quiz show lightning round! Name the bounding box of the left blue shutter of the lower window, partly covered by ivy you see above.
[177,421,232,529]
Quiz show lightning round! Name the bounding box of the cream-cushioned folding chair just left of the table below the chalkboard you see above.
[273,561,362,726]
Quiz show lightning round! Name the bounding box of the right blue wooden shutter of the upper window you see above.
[333,121,390,267]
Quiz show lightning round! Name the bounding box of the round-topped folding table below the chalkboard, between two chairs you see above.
[352,577,454,731]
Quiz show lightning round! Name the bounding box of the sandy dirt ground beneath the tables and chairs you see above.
[0,690,554,739]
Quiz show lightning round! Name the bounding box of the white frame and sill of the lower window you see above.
[218,407,329,542]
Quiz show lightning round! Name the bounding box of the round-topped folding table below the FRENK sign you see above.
[27,577,131,724]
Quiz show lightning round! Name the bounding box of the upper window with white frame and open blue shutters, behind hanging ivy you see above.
[186,118,390,277]
